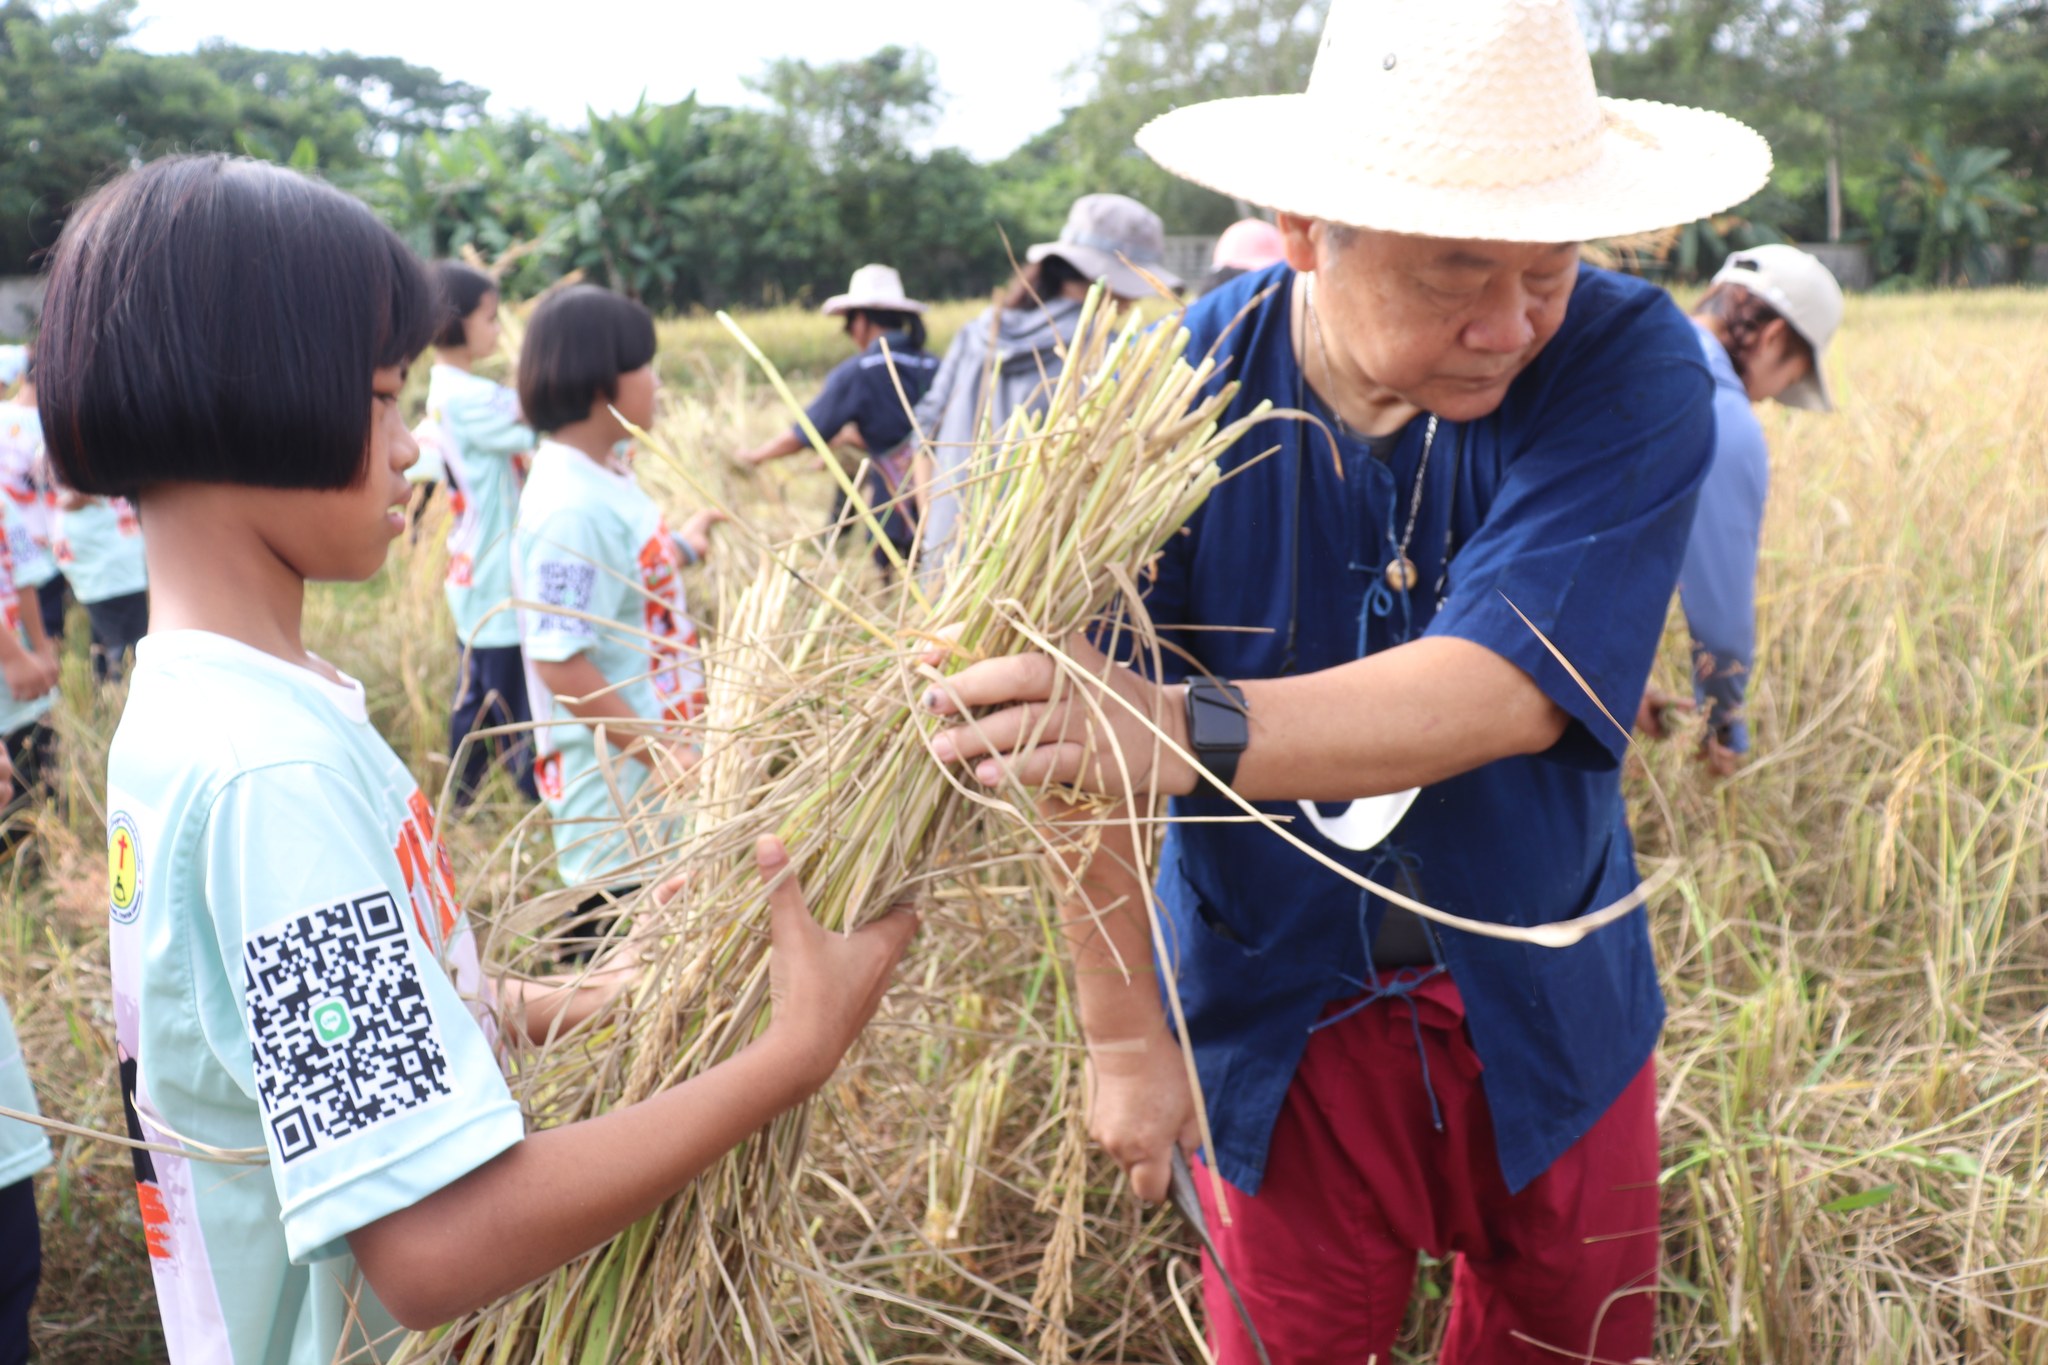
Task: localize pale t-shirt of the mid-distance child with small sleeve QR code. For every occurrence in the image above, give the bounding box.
[516,440,705,886]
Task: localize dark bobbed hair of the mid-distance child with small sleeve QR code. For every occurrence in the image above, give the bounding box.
[518,284,655,432]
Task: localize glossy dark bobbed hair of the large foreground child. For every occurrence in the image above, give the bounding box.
[37,156,434,495]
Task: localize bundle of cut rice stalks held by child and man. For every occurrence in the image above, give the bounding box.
[401,291,1264,1365]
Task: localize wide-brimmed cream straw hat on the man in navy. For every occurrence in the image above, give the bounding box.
[1137,0,1772,241]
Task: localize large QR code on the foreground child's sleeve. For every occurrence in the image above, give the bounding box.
[242,890,453,1162]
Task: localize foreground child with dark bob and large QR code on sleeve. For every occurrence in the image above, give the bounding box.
[41,156,911,1365]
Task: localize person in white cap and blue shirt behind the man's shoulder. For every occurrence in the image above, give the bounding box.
[1636,246,1841,778]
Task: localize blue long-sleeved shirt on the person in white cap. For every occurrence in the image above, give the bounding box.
[1677,327,1772,753]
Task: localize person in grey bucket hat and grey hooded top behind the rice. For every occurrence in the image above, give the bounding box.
[915,194,1182,579]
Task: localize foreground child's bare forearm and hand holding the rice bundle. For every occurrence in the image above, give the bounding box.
[348,839,915,1330]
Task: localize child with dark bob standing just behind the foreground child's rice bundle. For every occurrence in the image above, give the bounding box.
[516,284,719,913]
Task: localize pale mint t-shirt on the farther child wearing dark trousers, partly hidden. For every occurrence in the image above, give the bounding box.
[420,364,532,649]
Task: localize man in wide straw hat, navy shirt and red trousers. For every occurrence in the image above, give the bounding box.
[930,0,1769,1365]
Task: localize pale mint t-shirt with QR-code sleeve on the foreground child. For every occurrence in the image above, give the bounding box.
[106,630,524,1365]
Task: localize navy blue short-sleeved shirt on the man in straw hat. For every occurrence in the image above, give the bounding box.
[1147,266,1714,1193]
